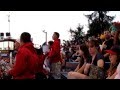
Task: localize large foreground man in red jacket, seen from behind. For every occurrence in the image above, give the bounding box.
[8,32,39,79]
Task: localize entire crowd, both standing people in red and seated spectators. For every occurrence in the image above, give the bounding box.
[0,30,120,79]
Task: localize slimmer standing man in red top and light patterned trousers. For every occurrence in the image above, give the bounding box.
[48,32,62,79]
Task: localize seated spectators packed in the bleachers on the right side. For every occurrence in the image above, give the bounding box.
[64,30,120,79]
